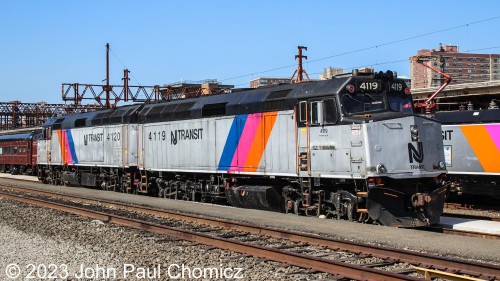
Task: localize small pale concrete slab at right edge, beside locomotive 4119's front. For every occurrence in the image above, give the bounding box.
[441,217,500,235]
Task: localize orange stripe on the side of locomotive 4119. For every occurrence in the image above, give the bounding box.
[243,112,278,172]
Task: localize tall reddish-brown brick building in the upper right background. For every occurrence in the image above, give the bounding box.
[410,45,500,89]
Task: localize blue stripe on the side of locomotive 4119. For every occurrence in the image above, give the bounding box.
[218,114,248,171]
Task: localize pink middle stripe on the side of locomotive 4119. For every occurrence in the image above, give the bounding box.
[229,113,262,171]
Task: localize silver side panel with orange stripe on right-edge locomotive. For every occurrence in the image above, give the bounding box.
[442,124,500,175]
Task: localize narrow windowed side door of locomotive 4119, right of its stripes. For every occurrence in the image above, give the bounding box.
[295,101,311,177]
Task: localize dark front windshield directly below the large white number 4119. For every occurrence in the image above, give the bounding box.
[342,93,386,114]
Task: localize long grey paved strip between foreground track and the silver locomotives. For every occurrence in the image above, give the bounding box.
[0,176,500,264]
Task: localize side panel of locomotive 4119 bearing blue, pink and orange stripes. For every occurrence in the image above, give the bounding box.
[216,111,296,175]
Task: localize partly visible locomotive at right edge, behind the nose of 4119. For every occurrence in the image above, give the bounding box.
[434,109,500,201]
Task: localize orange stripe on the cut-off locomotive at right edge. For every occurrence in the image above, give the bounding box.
[460,126,500,172]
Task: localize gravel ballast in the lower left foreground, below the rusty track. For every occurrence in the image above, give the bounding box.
[0,198,336,280]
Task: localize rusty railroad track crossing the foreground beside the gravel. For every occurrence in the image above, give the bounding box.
[0,183,500,280]
